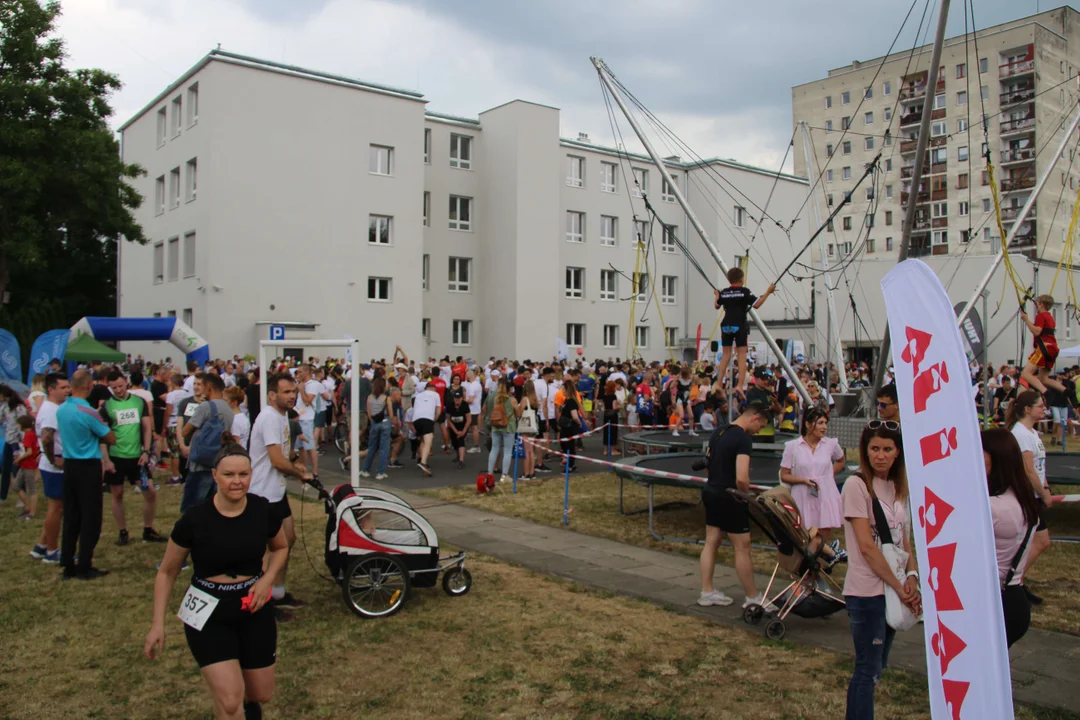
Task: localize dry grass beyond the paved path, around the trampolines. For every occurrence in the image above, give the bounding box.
[423,473,1080,635]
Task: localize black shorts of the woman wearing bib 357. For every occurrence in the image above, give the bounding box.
[184,578,278,670]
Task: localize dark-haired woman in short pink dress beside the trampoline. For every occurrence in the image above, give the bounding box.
[780,407,845,542]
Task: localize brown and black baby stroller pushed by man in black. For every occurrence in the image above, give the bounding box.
[728,486,845,640]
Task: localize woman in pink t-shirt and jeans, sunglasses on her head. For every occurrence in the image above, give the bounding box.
[840,420,920,720]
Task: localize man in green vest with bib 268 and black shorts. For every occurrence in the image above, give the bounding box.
[100,369,167,545]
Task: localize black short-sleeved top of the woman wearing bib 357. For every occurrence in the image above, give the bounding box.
[170,494,281,578]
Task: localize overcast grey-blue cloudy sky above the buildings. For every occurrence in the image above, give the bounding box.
[59,0,1062,167]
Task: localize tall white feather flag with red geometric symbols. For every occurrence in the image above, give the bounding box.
[881,260,1013,720]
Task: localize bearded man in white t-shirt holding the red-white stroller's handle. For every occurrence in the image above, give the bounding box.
[247,373,312,622]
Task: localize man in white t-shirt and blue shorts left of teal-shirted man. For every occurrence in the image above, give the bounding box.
[30,372,71,565]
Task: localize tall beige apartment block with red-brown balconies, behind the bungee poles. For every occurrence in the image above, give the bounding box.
[792,8,1080,363]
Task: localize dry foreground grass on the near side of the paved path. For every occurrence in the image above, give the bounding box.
[0,489,1077,720]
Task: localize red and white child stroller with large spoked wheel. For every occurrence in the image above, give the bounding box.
[309,480,472,617]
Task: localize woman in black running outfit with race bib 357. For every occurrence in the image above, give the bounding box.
[150,443,288,720]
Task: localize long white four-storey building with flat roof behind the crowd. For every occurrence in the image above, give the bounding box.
[117,50,822,359]
